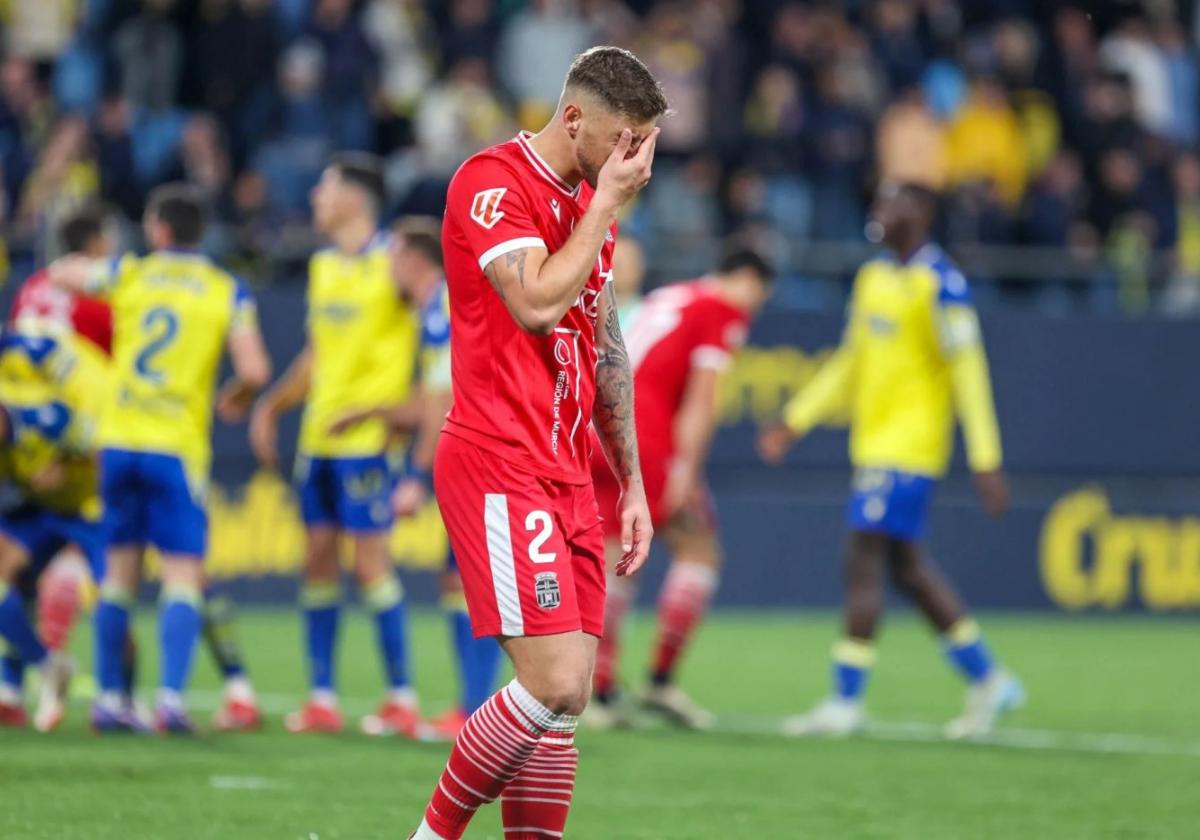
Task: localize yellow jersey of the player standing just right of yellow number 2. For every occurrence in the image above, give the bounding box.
[300,234,421,458]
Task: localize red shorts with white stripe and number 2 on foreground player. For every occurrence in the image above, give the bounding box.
[433,432,605,637]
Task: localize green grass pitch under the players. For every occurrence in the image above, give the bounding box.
[0,611,1200,840]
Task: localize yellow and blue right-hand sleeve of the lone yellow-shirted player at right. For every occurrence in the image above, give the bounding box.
[935,269,1003,473]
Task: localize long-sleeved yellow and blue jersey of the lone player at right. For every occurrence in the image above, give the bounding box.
[784,244,1001,478]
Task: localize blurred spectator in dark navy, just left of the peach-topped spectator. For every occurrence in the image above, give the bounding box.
[809,64,872,240]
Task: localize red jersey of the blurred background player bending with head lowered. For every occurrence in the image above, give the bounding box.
[625,280,748,461]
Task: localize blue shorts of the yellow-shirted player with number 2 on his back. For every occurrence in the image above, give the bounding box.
[100,449,209,558]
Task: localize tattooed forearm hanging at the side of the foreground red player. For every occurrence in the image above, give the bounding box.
[593,283,642,481]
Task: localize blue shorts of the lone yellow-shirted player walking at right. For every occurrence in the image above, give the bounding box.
[846,469,936,541]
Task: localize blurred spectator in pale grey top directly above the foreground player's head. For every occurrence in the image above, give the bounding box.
[497,0,592,128]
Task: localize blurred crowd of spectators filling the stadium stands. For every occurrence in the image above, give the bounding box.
[0,0,1200,312]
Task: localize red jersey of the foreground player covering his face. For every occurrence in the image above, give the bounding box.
[442,133,617,484]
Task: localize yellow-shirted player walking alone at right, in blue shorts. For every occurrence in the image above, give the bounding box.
[760,182,1024,738]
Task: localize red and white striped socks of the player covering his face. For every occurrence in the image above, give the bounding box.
[413,679,578,840]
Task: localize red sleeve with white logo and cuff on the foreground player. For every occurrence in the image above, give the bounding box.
[446,157,546,269]
